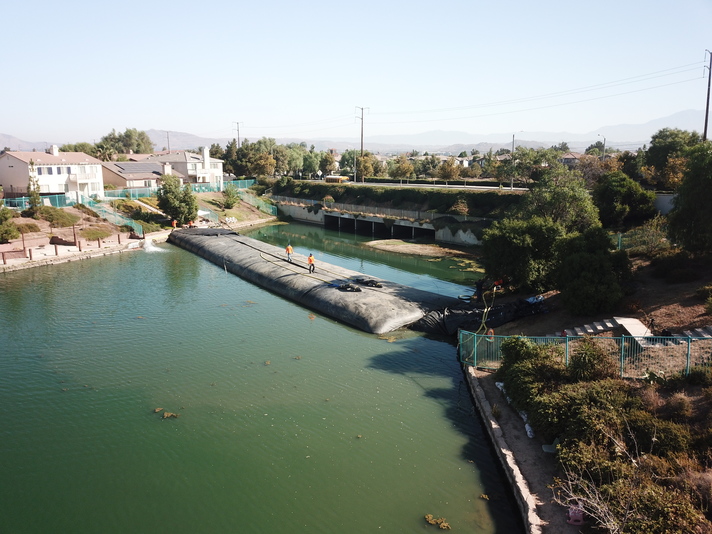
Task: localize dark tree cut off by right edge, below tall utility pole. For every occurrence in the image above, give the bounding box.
[668,141,712,254]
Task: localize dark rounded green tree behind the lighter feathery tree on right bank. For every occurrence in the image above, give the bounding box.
[593,171,655,228]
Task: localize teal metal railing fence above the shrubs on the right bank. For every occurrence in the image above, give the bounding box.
[458,330,712,378]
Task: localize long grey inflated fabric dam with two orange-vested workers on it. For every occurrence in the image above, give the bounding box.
[168,228,458,334]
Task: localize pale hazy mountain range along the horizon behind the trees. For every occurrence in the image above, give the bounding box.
[0,109,705,155]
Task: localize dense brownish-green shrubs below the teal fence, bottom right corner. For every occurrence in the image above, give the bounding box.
[497,337,712,534]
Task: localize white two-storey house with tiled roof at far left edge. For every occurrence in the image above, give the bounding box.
[0,145,104,198]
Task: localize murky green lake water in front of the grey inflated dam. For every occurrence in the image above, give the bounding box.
[0,225,522,534]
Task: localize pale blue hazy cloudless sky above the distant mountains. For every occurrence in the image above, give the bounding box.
[5,0,712,143]
